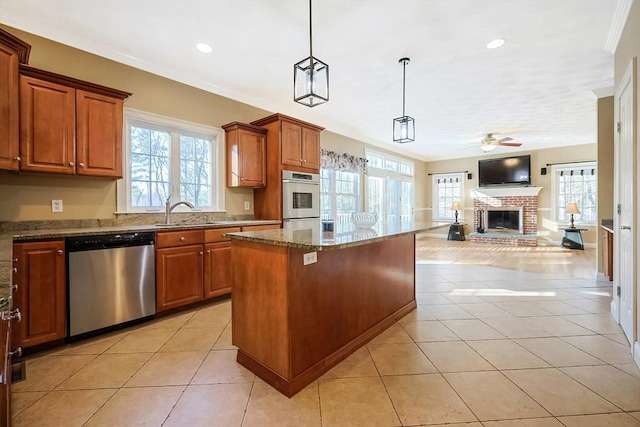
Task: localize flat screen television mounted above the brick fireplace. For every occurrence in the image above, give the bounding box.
[478,155,531,187]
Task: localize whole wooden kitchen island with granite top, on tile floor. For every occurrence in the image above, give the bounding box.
[228,223,448,397]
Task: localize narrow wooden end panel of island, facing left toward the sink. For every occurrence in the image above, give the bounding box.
[231,240,290,379]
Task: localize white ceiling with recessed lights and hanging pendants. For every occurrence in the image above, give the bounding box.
[0,0,616,161]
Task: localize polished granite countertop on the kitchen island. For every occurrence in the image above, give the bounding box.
[227,221,451,251]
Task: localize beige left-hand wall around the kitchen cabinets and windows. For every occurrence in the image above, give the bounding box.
[0,26,424,221]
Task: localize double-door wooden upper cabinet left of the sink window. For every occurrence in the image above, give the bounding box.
[19,65,131,178]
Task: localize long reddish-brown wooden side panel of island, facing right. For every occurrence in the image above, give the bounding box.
[289,234,415,377]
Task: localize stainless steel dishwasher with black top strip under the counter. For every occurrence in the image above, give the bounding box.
[66,232,156,340]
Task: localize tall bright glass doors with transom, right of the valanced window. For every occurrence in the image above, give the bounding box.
[365,150,415,222]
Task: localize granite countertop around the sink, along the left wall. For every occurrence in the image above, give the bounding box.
[0,220,280,311]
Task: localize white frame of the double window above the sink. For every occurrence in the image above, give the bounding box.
[116,108,226,214]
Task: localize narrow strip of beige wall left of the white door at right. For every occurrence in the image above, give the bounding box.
[597,96,614,272]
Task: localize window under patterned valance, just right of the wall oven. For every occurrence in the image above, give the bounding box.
[320,169,361,229]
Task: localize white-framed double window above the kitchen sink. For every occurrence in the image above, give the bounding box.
[118,109,224,212]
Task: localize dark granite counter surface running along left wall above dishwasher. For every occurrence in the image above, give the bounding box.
[0,219,280,311]
